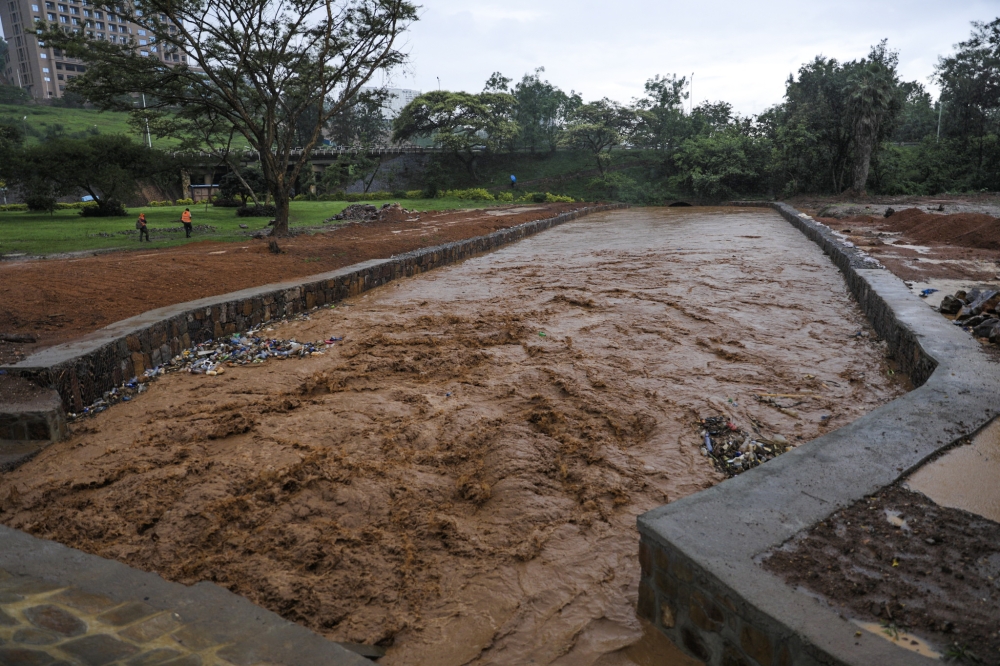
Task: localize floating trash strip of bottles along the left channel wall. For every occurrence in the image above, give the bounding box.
[67,315,344,421]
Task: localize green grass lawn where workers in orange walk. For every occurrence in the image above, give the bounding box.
[0,199,495,256]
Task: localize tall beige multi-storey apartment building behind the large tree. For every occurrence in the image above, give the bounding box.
[0,0,187,100]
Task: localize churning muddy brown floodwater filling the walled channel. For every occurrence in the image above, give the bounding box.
[0,208,902,666]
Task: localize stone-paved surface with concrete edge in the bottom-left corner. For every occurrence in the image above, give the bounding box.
[0,525,371,666]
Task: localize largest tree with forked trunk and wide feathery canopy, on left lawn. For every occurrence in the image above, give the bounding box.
[42,0,417,234]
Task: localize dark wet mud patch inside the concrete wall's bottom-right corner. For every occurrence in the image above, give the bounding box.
[764,487,1000,666]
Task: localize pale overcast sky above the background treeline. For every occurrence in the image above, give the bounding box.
[380,0,1000,114]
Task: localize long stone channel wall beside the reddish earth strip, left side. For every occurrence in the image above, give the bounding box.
[0,204,627,412]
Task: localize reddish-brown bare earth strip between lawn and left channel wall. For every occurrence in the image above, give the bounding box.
[0,204,584,363]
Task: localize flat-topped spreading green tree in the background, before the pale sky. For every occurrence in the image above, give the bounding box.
[393,90,518,178]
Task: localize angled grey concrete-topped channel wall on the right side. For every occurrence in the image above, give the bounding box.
[638,203,1000,666]
